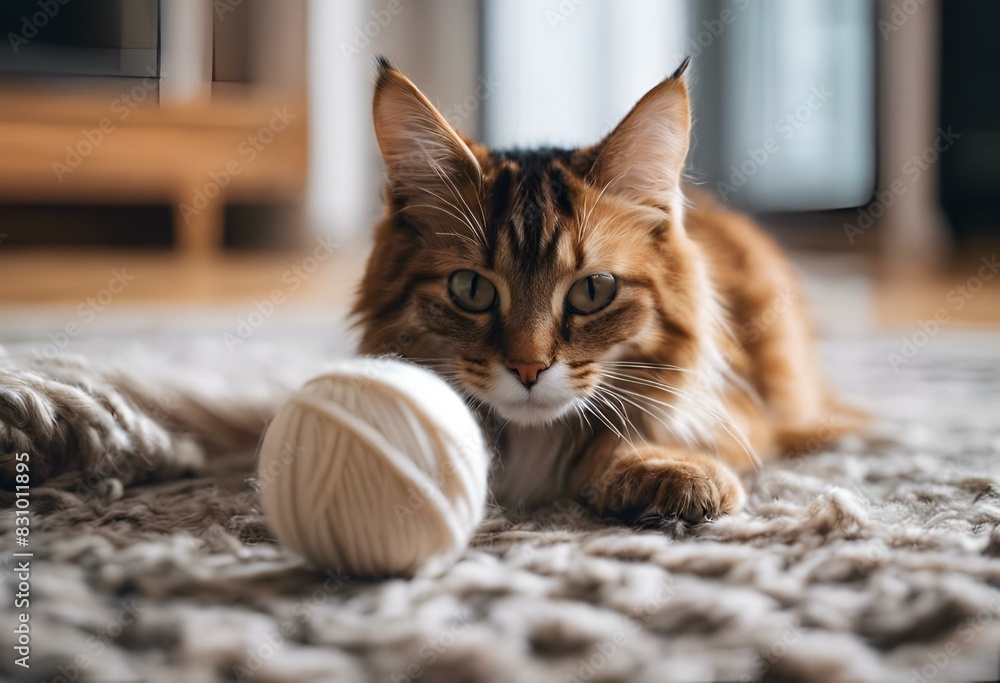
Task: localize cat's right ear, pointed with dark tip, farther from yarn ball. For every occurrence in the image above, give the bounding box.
[596,57,691,206]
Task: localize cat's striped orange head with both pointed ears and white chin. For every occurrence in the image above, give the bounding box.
[355,60,707,424]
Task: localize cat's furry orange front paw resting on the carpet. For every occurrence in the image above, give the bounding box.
[588,449,745,524]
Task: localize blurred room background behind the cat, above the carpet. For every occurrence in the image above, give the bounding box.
[0,0,1000,350]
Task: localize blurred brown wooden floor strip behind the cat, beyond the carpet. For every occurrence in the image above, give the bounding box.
[0,245,1000,332]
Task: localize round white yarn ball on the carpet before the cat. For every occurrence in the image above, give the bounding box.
[258,358,489,577]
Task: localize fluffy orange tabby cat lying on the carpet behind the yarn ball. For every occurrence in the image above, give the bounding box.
[353,57,857,525]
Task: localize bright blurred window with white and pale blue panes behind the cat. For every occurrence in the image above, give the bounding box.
[483,0,876,211]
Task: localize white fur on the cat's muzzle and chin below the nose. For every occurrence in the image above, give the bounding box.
[477,363,576,426]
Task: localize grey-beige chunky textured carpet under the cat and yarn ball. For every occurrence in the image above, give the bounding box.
[0,328,1000,683]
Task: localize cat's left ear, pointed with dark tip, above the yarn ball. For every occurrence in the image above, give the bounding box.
[372,57,482,194]
